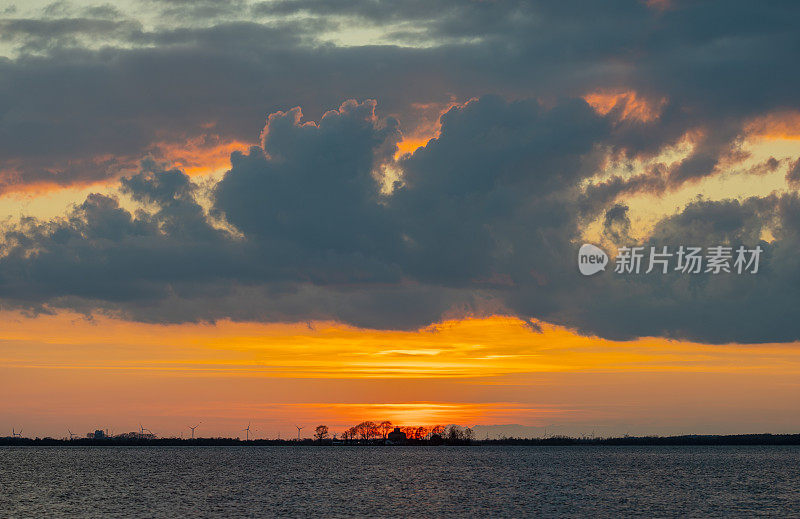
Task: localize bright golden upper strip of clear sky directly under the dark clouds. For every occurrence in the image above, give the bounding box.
[0,313,800,378]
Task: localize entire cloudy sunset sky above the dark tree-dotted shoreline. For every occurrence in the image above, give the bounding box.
[0,0,800,438]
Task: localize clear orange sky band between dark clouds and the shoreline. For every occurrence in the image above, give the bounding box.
[0,313,800,437]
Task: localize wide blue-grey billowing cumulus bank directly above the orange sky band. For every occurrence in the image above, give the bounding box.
[0,96,800,342]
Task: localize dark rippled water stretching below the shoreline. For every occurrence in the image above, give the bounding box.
[0,447,800,517]
